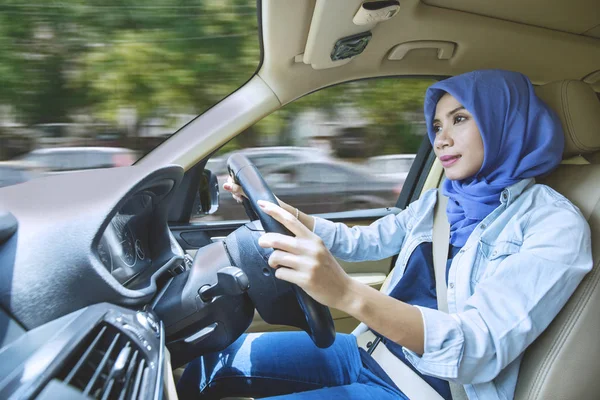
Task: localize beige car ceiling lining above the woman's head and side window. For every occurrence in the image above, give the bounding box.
[258,0,600,104]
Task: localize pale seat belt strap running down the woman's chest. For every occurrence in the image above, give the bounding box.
[431,189,468,400]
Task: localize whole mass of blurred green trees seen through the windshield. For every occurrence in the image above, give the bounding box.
[0,0,260,133]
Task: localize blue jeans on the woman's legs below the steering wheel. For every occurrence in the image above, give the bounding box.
[177,332,407,400]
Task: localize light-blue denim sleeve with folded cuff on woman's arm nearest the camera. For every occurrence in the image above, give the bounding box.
[404,202,592,384]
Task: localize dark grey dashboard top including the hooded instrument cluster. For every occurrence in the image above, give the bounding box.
[0,165,184,329]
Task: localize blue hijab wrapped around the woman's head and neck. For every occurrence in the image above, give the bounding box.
[424,70,564,247]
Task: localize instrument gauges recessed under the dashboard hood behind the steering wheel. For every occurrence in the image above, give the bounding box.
[96,193,153,285]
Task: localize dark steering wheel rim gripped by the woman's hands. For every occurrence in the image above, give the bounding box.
[227,154,335,348]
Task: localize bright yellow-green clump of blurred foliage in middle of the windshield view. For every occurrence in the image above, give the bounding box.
[76,32,194,136]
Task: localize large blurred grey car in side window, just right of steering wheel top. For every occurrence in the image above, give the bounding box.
[215,160,401,219]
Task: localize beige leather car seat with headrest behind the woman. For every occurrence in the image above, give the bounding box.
[515,81,600,400]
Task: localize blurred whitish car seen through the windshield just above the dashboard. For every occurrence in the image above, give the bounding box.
[18,147,138,172]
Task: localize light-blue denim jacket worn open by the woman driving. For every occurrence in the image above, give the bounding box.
[314,179,592,400]
